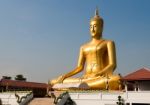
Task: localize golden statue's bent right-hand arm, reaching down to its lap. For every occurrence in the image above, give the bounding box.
[96,41,116,76]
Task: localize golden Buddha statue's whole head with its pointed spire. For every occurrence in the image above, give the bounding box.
[90,9,103,38]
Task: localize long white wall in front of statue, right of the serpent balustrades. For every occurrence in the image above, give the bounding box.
[69,91,150,105]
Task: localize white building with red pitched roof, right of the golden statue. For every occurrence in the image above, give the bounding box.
[123,68,150,91]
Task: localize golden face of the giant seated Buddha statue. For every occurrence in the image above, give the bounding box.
[90,20,102,37]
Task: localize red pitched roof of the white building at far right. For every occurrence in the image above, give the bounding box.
[122,68,150,81]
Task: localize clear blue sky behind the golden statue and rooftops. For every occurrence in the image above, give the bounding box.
[0,0,150,82]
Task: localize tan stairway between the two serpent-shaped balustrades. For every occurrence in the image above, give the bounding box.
[28,98,54,105]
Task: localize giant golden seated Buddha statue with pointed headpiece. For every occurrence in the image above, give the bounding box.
[49,10,120,90]
